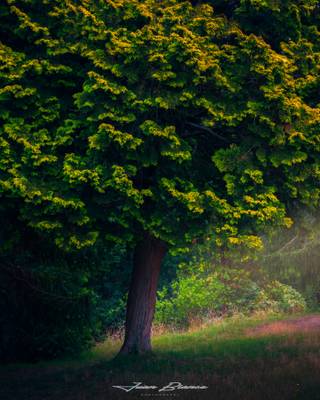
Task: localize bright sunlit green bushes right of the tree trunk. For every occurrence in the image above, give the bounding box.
[155,265,306,326]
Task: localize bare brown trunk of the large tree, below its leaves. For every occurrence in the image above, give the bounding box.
[120,234,166,354]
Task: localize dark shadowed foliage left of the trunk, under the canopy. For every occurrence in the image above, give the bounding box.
[0,242,130,362]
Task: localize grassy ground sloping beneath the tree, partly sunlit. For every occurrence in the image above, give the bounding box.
[0,315,320,400]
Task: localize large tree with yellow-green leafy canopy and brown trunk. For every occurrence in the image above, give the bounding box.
[0,0,320,353]
